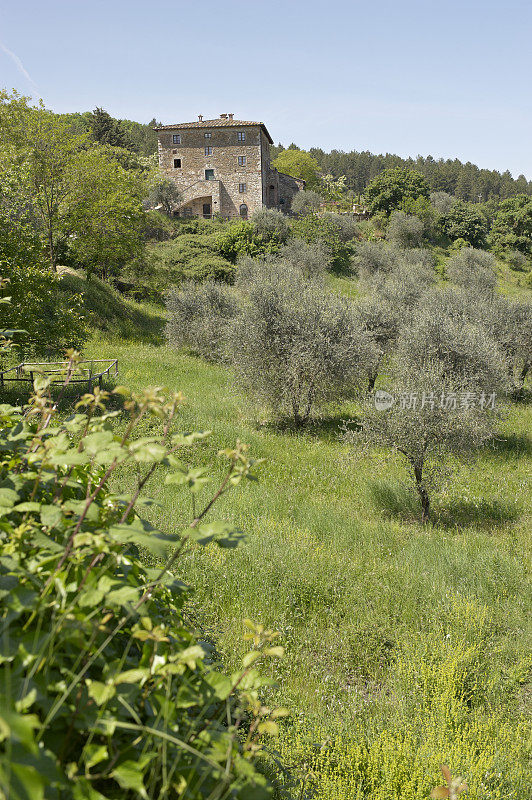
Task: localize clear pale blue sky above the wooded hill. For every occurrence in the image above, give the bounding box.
[0,0,532,179]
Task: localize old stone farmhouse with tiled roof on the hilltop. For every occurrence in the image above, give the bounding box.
[156,114,305,219]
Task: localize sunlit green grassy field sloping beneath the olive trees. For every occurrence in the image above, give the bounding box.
[75,268,532,800]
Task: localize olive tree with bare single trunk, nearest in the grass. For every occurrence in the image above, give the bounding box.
[354,362,497,522]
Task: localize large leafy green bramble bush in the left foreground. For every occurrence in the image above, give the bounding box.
[0,374,285,800]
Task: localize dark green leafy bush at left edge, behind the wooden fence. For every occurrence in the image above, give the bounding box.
[0,261,88,358]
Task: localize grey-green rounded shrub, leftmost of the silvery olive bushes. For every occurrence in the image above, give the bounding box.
[166,281,237,361]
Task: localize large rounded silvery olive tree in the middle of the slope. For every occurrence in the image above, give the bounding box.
[227,265,375,425]
